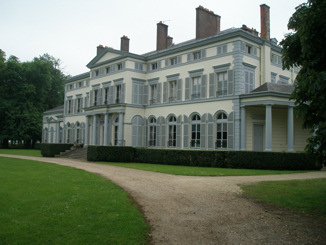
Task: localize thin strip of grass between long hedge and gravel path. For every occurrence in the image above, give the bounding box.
[101,162,308,176]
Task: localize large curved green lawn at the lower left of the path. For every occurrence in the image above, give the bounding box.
[0,157,149,244]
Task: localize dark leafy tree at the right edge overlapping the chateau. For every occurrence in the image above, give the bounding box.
[280,0,326,163]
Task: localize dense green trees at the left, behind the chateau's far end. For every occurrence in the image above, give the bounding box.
[0,50,66,147]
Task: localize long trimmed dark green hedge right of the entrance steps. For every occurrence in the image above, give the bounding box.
[87,146,322,170]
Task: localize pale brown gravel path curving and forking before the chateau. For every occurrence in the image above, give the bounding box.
[0,154,326,245]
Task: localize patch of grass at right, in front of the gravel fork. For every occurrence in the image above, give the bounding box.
[241,179,326,219]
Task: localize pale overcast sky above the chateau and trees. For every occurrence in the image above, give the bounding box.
[0,0,306,76]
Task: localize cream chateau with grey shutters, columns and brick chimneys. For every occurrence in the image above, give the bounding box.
[43,4,309,151]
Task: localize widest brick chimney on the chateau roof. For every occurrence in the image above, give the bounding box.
[196,6,221,39]
